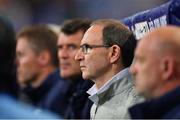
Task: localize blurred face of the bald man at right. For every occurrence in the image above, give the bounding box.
[131,40,161,97]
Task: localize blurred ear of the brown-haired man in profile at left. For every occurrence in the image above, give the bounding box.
[38,51,51,66]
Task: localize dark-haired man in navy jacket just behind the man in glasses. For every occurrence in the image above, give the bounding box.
[44,19,92,119]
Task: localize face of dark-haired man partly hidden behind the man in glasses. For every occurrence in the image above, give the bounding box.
[58,31,83,78]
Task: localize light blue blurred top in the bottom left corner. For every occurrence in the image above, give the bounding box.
[0,93,58,119]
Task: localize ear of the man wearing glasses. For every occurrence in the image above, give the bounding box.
[110,45,121,63]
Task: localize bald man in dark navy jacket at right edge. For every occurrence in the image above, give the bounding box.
[129,26,180,119]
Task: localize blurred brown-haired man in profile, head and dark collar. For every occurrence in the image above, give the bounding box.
[16,25,60,107]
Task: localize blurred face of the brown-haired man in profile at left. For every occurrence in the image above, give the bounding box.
[16,37,40,85]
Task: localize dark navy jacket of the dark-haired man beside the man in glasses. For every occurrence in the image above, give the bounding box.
[43,78,92,119]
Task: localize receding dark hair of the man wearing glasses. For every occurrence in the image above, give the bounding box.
[91,19,137,67]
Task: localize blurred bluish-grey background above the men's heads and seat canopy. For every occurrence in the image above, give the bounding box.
[0,0,168,30]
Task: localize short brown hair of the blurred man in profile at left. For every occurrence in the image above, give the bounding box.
[16,25,58,66]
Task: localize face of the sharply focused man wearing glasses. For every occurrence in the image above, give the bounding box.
[75,25,110,80]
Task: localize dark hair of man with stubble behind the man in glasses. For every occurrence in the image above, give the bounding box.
[61,18,92,35]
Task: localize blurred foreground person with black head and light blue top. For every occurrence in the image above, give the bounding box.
[0,17,57,119]
